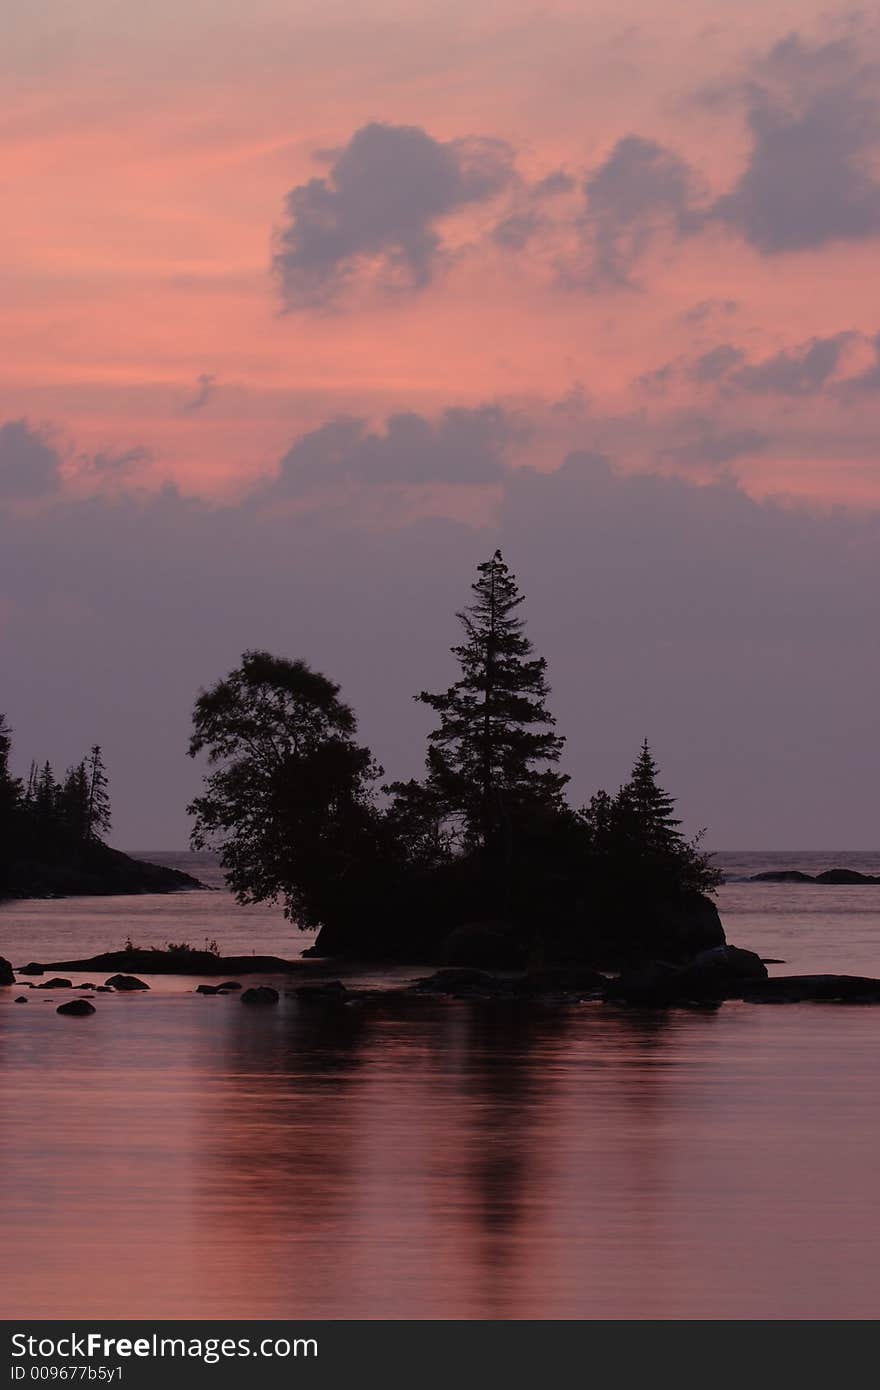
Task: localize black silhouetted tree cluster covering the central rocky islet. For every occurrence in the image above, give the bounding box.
[189,552,720,958]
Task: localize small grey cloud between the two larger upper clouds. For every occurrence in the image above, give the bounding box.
[581,135,701,286]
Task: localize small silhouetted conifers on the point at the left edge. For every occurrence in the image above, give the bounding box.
[0,714,111,897]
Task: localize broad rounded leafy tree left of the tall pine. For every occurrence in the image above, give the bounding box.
[189,651,381,927]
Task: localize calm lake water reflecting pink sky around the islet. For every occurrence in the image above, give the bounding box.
[0,852,880,1319]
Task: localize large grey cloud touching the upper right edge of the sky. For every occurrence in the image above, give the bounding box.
[712,33,880,256]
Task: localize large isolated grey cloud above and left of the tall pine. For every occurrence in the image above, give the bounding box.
[274,122,514,309]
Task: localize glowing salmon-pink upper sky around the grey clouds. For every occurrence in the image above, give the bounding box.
[6,0,880,503]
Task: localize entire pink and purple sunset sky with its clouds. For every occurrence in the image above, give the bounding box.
[0,0,880,849]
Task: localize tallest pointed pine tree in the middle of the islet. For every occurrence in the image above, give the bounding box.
[416,550,569,859]
